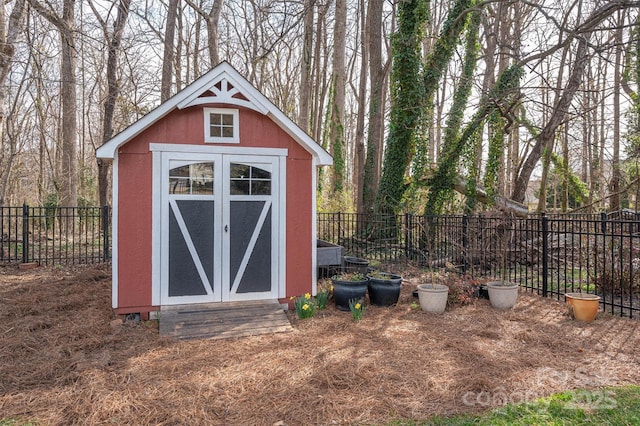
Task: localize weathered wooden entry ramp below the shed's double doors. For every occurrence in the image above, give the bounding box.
[158,300,293,339]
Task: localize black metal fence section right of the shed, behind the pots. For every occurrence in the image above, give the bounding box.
[318,213,640,317]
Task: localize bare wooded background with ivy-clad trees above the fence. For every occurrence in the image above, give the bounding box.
[0,0,640,213]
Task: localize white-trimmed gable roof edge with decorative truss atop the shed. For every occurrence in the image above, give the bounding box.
[96,62,333,166]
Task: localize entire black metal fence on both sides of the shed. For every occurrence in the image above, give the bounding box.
[0,205,640,317]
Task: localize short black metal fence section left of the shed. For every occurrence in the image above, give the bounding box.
[0,204,111,265]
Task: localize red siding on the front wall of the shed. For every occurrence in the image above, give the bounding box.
[118,105,315,312]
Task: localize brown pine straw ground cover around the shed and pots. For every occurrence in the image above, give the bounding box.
[0,267,640,425]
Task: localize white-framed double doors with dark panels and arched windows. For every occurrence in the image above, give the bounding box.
[161,152,279,304]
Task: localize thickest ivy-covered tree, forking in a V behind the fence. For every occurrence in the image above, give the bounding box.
[376,0,475,213]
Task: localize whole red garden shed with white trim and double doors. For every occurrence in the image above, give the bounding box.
[97,62,332,315]
